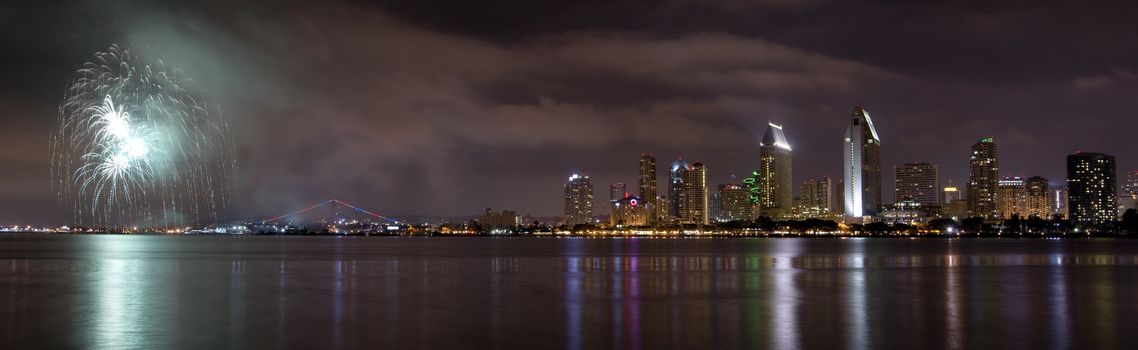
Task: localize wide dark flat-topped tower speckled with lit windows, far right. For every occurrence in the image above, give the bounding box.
[1067,152,1118,226]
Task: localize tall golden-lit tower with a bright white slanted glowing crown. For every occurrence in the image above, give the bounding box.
[759,123,794,217]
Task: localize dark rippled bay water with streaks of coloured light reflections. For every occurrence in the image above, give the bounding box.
[0,235,1138,349]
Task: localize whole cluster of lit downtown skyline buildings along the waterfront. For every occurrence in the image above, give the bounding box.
[562,107,1138,232]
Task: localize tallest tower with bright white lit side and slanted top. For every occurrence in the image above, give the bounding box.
[842,107,881,217]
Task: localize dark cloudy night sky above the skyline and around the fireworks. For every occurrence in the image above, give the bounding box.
[0,0,1138,225]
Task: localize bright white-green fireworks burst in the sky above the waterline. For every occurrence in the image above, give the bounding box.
[51,45,236,227]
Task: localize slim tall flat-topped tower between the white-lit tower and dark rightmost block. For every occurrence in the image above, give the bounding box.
[967,138,999,218]
